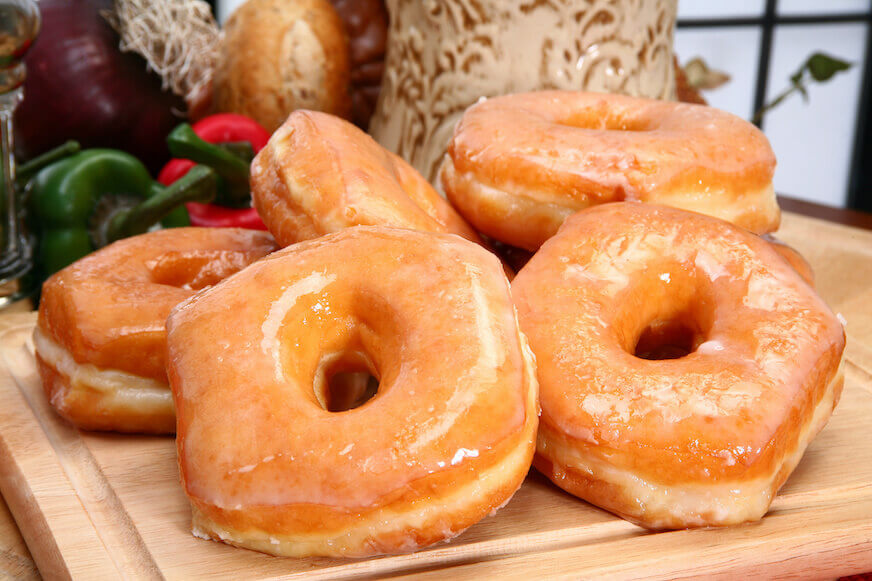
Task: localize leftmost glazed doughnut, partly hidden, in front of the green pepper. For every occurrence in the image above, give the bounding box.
[33,228,275,434]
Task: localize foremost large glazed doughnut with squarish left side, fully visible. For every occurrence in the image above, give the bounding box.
[167,227,538,557]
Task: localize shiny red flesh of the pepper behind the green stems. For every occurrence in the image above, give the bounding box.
[157,113,270,230]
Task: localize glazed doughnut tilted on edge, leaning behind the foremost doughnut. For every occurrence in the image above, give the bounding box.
[251,111,480,246]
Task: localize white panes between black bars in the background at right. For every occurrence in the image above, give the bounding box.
[675,0,870,206]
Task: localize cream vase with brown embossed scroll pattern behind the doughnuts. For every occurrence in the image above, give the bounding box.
[370,0,677,181]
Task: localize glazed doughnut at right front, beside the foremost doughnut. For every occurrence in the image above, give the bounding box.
[512,202,845,529]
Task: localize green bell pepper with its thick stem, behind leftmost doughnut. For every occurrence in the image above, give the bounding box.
[27,149,217,276]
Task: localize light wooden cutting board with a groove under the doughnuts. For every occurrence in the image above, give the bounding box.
[0,215,872,579]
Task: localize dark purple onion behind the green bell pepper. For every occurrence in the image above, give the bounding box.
[15,0,185,172]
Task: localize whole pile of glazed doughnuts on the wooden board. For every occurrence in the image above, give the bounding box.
[36,92,845,557]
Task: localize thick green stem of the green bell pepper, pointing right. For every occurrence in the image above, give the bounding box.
[105,165,218,244]
